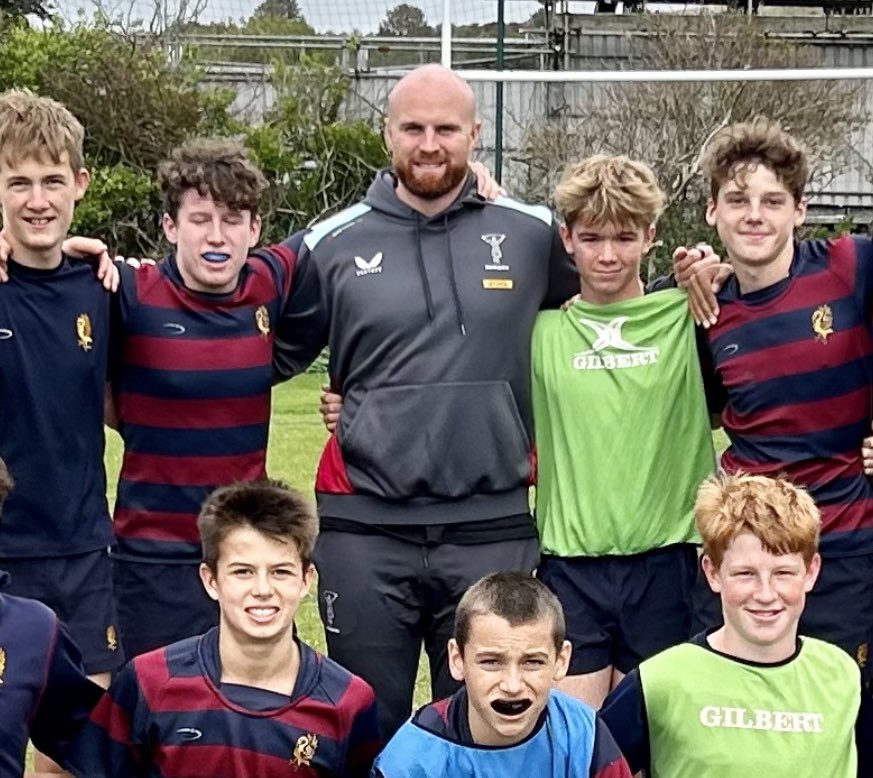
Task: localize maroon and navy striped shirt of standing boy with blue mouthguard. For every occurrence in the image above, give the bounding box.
[112,244,297,563]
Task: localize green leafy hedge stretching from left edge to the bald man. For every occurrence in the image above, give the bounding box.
[0,17,386,256]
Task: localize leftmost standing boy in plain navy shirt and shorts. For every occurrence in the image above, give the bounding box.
[0,91,124,728]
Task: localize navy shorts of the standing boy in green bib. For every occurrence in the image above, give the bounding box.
[537,543,697,675]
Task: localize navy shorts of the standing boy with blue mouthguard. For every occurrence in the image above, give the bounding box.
[115,558,218,658]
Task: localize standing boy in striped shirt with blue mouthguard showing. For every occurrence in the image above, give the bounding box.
[111,140,320,656]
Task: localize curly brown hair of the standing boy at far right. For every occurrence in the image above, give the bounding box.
[700,116,809,203]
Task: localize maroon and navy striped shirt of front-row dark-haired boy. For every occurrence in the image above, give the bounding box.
[65,628,380,778]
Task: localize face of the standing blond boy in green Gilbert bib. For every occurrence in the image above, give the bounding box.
[561,219,655,305]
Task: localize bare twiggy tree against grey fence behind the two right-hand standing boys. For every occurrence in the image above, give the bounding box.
[520,14,868,269]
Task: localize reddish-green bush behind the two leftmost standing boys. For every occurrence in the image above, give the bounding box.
[0,22,240,256]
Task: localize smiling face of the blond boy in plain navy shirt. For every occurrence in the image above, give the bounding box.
[0,152,89,268]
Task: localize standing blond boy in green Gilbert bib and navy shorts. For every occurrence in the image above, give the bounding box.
[531,155,714,708]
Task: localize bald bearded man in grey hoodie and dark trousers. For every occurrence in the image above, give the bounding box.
[275,65,578,737]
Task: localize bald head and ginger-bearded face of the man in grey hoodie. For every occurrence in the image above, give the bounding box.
[385,66,480,214]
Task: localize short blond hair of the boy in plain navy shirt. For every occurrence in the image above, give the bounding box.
[0,89,85,171]
